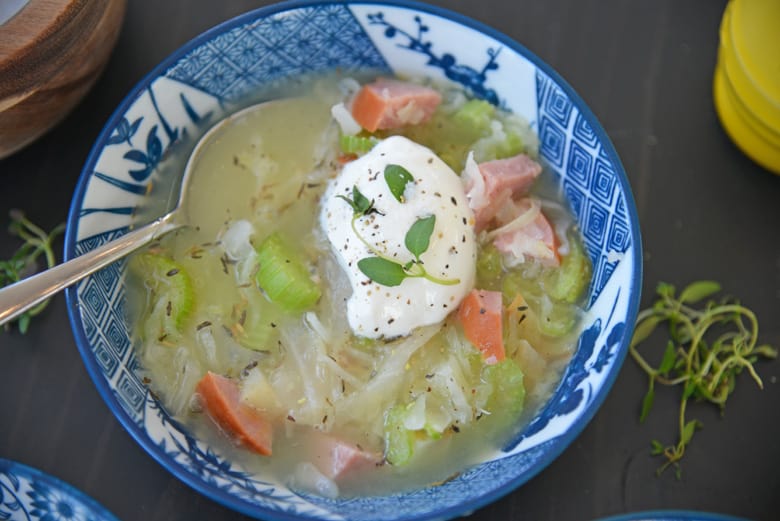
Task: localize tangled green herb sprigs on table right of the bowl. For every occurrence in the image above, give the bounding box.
[629,281,777,479]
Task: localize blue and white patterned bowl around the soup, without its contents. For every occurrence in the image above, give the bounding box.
[66,0,641,520]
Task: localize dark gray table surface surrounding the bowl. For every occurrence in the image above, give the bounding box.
[0,0,780,521]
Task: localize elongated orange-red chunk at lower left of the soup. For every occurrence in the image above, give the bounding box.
[195,371,273,456]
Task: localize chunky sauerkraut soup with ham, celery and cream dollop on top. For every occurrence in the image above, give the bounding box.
[128,77,590,497]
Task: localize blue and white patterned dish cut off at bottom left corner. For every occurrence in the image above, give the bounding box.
[0,459,118,521]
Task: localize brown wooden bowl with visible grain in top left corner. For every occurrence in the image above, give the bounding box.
[0,0,126,159]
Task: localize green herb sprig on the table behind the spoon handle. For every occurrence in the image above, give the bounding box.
[0,210,65,333]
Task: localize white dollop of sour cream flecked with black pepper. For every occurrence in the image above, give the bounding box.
[320,136,477,338]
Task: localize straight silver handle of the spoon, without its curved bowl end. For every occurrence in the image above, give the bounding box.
[0,212,181,326]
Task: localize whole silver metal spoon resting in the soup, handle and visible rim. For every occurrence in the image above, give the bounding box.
[0,102,278,326]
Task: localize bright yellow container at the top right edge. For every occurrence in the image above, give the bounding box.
[713,0,780,174]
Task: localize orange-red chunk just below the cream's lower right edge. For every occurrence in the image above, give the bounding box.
[458,289,506,364]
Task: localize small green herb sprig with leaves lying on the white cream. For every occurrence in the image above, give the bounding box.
[338,178,460,286]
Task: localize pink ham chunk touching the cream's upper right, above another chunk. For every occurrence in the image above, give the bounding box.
[466,154,542,233]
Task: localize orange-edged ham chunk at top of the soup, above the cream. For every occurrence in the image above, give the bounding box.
[352,78,441,132]
